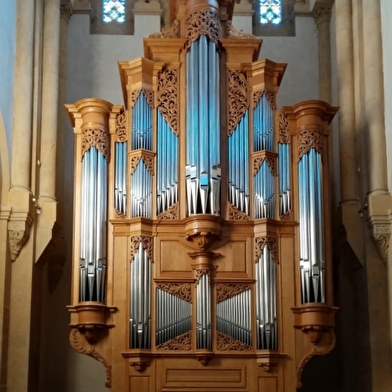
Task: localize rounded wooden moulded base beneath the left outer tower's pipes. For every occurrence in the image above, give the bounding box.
[68,301,117,344]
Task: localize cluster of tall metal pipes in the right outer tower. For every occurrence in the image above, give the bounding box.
[298,148,325,303]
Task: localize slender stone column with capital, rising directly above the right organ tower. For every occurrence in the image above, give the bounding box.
[313,0,332,103]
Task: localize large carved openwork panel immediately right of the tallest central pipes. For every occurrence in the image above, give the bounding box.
[227,70,249,136]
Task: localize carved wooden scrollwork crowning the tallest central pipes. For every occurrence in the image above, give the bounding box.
[185,10,220,49]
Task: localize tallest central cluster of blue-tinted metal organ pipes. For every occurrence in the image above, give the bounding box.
[185,35,221,215]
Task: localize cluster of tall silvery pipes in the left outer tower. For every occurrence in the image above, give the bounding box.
[80,147,107,302]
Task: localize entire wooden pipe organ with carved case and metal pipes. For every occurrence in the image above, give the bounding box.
[66,0,337,392]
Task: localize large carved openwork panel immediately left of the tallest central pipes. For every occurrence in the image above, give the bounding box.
[158,69,178,136]
